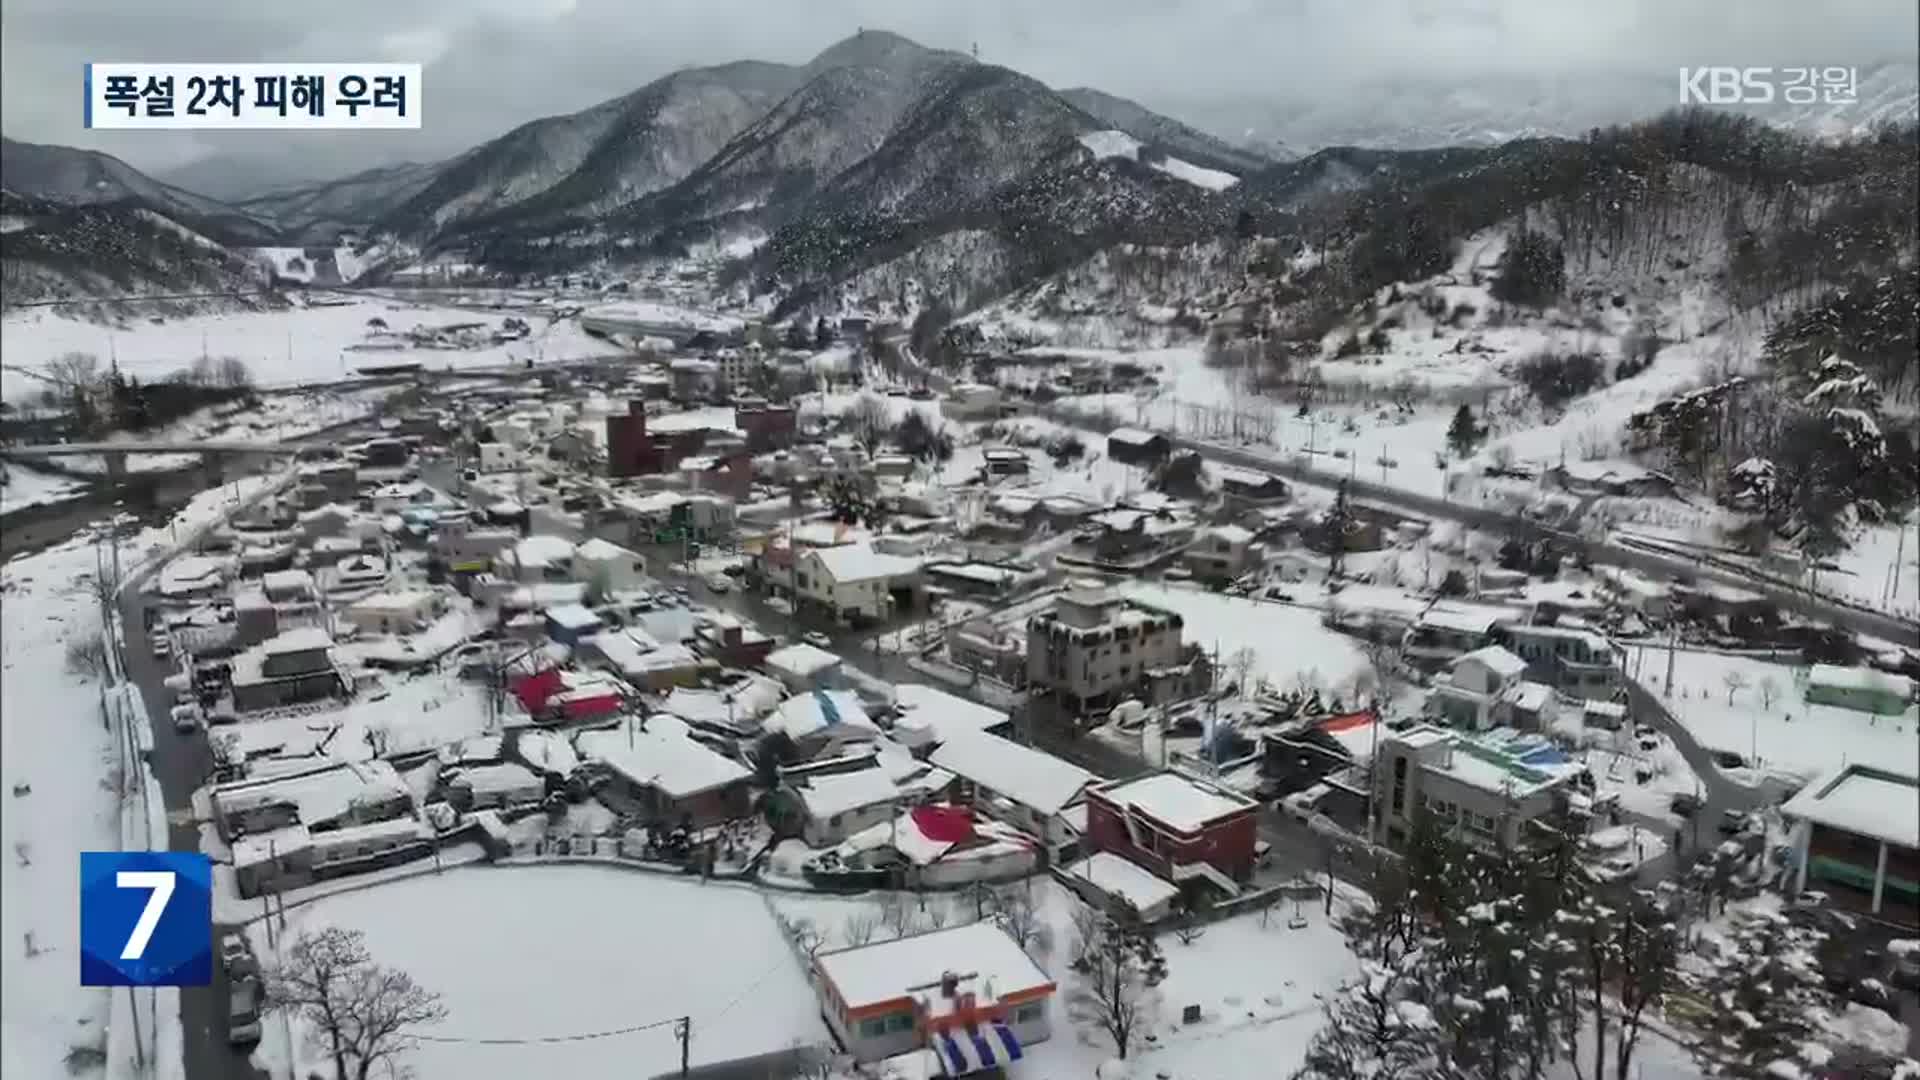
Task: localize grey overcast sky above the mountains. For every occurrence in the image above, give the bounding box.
[0,0,1920,179]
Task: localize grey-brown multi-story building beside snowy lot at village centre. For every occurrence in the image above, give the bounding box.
[1027,588,1185,713]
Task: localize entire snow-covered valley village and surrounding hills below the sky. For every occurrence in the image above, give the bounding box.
[0,15,1920,1080]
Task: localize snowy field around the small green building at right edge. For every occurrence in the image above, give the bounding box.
[1626,646,1920,778]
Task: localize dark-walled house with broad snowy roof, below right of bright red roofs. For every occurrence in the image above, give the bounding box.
[576,715,753,826]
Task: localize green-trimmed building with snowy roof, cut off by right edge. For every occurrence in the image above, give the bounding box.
[1780,761,1920,926]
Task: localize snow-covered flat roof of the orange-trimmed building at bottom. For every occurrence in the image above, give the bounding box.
[814,922,1054,1009]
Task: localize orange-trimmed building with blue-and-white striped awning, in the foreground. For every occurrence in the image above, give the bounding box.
[812,922,1056,1076]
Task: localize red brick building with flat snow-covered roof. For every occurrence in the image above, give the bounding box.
[1087,773,1260,896]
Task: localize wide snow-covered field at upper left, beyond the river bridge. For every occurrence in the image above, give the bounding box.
[0,298,614,400]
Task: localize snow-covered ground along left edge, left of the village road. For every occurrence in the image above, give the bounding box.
[0,479,257,1078]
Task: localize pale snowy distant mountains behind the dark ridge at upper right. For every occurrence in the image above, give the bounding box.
[1164,61,1920,156]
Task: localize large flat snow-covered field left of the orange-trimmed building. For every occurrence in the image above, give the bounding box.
[253,867,828,1080]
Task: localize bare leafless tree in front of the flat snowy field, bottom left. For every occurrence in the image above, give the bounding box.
[265,926,447,1080]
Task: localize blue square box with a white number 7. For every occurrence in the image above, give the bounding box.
[81,851,213,986]
